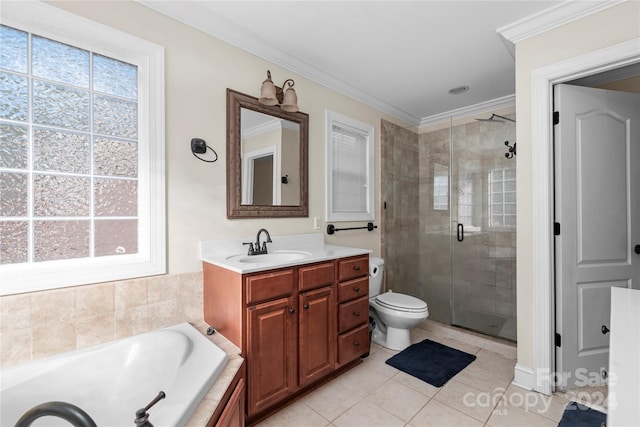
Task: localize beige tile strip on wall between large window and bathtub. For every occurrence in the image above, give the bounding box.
[0,272,203,367]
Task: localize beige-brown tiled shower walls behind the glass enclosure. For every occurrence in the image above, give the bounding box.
[381,115,516,339]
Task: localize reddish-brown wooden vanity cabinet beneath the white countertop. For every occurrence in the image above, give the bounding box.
[203,256,369,421]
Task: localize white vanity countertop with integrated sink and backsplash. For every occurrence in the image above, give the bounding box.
[200,233,372,274]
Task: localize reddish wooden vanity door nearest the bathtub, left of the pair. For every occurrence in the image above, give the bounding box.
[247,297,297,415]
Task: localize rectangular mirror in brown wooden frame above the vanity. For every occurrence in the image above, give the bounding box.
[227,89,309,218]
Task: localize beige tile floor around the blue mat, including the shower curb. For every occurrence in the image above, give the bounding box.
[258,320,596,427]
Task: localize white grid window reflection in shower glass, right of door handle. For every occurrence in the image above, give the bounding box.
[489,168,516,228]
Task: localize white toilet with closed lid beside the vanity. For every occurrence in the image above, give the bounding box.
[369,257,429,350]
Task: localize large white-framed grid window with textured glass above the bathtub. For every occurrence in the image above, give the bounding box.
[0,2,166,294]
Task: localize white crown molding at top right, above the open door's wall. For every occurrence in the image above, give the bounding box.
[496,0,625,43]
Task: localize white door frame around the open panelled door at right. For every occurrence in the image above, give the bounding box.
[528,38,640,395]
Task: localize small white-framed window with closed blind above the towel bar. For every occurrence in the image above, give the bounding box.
[327,111,375,221]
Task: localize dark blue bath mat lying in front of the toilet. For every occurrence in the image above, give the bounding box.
[386,340,476,387]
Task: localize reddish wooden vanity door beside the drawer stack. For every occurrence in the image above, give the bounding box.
[298,287,336,386]
